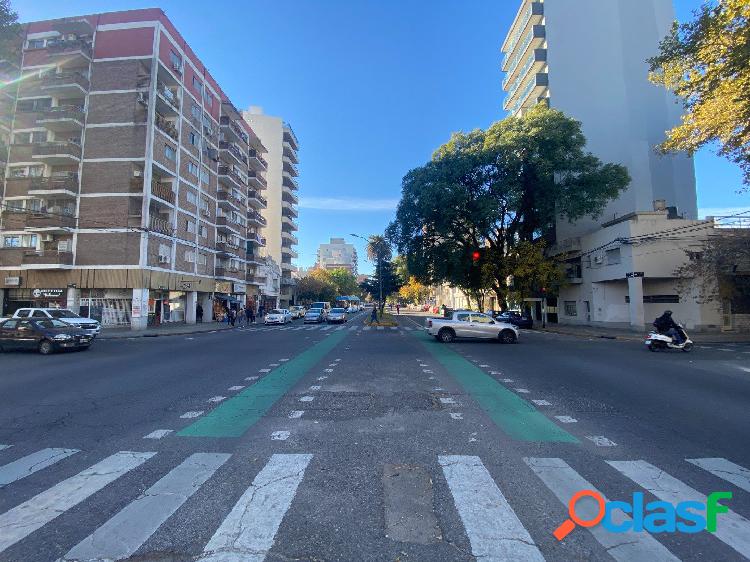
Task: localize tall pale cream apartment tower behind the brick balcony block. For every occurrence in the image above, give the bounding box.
[243,106,299,309]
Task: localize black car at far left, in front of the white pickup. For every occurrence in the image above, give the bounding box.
[0,318,94,355]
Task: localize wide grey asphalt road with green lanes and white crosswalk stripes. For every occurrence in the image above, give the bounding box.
[0,315,750,562]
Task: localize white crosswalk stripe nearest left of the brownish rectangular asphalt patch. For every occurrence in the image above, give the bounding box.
[199,455,312,562]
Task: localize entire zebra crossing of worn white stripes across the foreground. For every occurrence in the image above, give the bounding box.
[0,447,750,562]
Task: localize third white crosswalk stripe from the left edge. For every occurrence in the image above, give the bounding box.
[63,453,231,561]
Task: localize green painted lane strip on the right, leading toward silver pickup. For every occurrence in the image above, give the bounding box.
[415,332,579,443]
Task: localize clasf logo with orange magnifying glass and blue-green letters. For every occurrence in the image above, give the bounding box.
[553,490,732,541]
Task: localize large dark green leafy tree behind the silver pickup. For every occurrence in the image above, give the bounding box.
[388,104,630,305]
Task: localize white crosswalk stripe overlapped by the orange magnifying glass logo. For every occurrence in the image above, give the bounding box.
[523,458,679,562]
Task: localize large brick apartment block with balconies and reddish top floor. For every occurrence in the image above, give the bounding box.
[0,9,267,329]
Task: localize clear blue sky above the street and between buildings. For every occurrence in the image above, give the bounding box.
[20,0,750,272]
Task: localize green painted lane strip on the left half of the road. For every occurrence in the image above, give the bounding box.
[177,330,347,437]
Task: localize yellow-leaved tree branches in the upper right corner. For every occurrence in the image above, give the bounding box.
[648,0,750,189]
